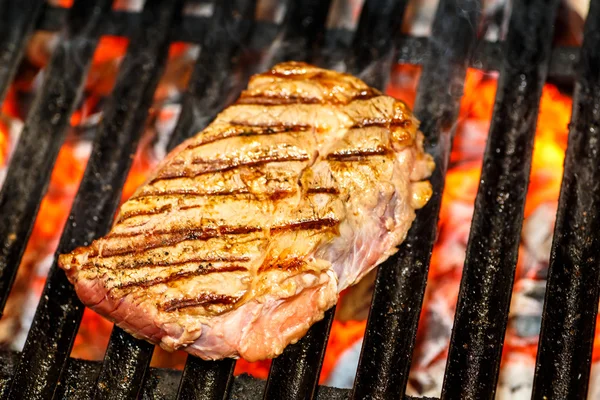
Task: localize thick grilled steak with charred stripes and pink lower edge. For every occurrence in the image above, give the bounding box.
[59,62,434,361]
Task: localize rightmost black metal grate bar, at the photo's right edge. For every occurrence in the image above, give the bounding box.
[533,1,600,399]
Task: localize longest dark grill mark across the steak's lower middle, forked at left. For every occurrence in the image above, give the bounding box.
[98,218,340,257]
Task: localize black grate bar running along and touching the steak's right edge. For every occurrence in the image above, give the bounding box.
[352,0,481,399]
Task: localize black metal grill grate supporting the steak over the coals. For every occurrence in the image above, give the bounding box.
[0,0,600,399]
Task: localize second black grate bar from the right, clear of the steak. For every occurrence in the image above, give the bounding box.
[442,0,558,399]
